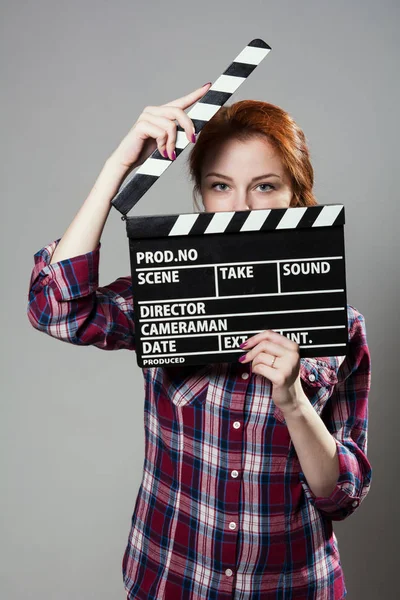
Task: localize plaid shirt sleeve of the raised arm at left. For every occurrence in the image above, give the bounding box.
[27,238,136,350]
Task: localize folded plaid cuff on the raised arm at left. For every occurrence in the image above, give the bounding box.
[30,238,101,302]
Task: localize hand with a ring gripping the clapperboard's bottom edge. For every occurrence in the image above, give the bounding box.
[240,330,304,410]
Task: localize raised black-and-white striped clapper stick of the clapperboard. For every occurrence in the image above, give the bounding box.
[111,39,271,220]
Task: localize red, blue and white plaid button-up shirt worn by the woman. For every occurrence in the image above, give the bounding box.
[27,239,372,600]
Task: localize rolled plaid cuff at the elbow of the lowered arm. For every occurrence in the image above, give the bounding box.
[299,437,372,520]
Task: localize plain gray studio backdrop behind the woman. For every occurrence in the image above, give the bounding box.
[0,0,399,600]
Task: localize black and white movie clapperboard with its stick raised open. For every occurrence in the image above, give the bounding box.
[112,39,348,367]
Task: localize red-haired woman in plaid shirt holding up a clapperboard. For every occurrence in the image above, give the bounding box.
[28,84,372,600]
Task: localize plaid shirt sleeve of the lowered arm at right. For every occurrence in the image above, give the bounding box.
[300,307,372,521]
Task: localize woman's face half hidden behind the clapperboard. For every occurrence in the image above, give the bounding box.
[201,137,293,212]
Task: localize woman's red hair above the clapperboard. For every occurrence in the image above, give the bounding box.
[187,100,318,209]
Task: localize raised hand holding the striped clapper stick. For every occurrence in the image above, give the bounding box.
[106,82,211,171]
